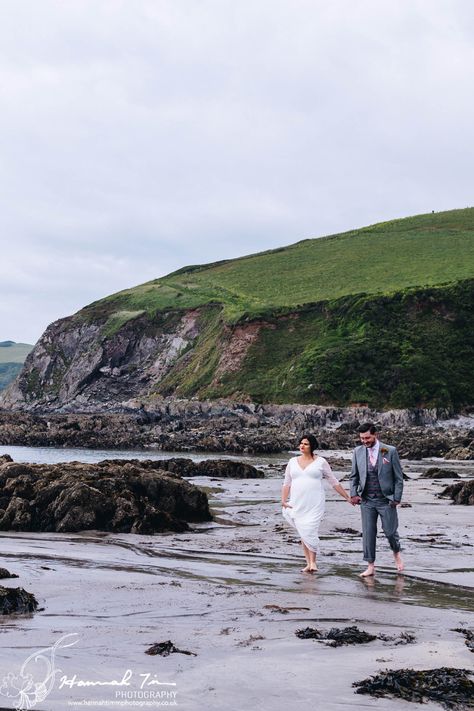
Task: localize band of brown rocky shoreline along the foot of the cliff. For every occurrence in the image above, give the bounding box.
[0,400,474,460]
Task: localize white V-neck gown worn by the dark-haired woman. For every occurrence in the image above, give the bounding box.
[282,455,339,553]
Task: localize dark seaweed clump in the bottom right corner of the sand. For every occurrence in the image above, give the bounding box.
[352,667,474,709]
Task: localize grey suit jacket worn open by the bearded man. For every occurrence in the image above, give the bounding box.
[351,442,403,501]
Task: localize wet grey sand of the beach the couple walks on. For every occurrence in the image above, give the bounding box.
[0,453,474,711]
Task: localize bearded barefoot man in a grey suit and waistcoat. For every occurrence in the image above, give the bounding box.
[351,422,403,578]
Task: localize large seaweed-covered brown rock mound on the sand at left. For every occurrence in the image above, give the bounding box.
[0,460,211,534]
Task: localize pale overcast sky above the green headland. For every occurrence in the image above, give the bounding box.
[0,0,474,343]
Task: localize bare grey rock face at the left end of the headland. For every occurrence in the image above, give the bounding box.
[2,309,206,412]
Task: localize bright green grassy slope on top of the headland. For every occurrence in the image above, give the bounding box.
[79,208,474,330]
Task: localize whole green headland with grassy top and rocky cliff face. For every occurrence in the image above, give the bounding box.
[10,208,474,410]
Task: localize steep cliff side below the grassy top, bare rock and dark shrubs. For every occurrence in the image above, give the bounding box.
[1,280,474,412]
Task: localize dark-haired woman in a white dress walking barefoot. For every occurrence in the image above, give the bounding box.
[281,434,351,573]
